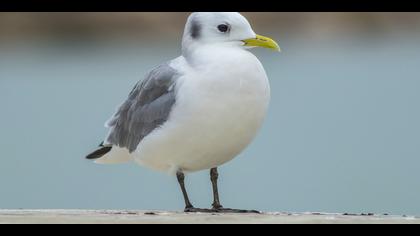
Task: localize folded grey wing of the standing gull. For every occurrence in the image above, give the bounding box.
[105,63,179,153]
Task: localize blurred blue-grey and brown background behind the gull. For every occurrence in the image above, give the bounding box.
[0,12,420,215]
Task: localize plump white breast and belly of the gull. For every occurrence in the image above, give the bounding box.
[132,49,270,173]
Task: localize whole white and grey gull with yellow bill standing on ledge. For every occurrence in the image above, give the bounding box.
[86,12,280,213]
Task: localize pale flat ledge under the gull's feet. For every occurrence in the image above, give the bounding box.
[0,210,420,224]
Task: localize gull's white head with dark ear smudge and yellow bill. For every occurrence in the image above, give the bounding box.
[182,12,280,54]
